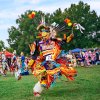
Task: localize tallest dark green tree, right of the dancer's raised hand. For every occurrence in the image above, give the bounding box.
[64,1,100,48]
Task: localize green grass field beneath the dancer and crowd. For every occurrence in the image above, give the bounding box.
[0,66,100,100]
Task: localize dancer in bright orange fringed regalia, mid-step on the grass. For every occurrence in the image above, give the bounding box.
[28,13,77,96]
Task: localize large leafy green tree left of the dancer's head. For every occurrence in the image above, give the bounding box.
[8,10,47,54]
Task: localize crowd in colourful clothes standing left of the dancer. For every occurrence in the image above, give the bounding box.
[0,50,29,76]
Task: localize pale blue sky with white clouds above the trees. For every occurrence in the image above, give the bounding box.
[0,0,100,46]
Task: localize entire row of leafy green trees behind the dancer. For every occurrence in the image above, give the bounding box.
[1,1,100,54]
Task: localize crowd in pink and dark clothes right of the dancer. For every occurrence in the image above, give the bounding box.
[66,49,100,67]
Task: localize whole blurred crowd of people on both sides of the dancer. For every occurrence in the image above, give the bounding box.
[0,49,100,76]
